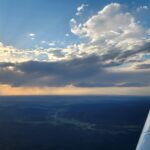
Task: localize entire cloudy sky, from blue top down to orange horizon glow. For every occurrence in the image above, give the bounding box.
[0,0,150,95]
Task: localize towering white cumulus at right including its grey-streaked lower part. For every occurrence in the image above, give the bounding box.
[70,3,150,69]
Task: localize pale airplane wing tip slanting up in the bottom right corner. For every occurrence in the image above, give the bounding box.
[136,112,150,150]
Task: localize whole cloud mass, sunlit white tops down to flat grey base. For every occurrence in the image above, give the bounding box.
[0,3,150,92]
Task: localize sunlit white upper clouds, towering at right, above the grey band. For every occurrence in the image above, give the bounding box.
[0,3,150,64]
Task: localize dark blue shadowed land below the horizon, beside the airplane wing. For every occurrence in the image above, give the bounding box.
[0,96,150,150]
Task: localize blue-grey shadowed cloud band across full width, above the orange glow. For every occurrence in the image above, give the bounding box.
[0,51,150,87]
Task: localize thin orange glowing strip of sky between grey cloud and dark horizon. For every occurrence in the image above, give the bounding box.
[0,84,150,96]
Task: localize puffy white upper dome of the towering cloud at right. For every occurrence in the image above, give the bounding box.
[70,3,148,49]
